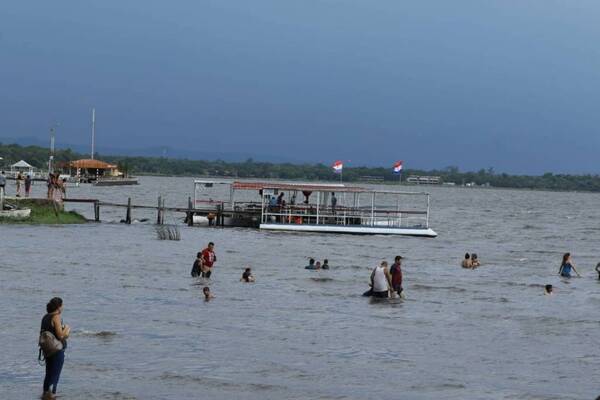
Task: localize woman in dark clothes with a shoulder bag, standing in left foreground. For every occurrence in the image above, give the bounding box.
[40,297,71,400]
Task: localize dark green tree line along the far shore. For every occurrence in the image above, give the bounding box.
[0,143,600,192]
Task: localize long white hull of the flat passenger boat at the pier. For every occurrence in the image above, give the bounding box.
[260,224,437,237]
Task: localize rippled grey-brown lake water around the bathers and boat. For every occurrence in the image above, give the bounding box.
[0,177,600,399]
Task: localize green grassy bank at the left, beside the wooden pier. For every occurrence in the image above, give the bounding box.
[0,199,87,225]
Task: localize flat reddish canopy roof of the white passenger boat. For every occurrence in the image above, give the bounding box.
[231,181,429,195]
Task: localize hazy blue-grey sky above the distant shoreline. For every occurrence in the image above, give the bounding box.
[0,0,600,174]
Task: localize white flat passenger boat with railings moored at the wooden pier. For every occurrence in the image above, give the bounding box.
[194,180,437,237]
